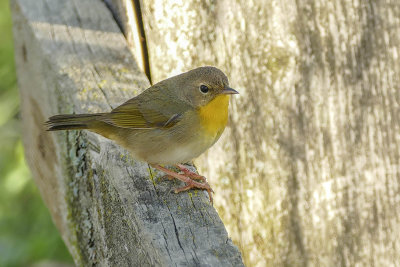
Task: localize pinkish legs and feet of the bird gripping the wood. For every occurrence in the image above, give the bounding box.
[152,165,214,204]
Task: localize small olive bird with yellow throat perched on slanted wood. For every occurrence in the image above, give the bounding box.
[46,67,238,202]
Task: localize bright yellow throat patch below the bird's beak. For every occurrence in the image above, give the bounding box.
[199,95,229,137]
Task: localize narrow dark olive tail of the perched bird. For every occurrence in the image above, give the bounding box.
[46,113,103,131]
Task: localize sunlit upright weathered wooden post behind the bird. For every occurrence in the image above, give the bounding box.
[108,0,400,266]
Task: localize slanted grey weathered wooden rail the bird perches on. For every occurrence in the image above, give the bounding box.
[11,0,243,266]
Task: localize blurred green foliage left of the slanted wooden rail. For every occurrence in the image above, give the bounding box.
[0,0,72,266]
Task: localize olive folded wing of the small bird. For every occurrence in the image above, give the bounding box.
[103,88,190,129]
